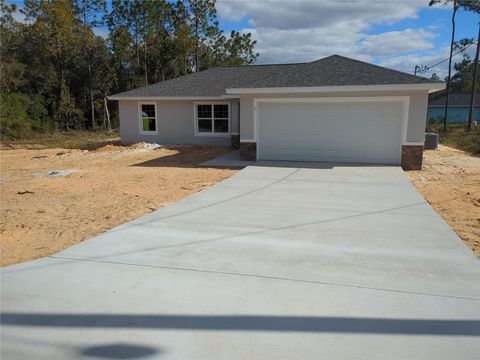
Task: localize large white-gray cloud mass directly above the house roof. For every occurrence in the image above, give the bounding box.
[218,0,443,73]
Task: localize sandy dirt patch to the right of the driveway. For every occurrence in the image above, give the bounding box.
[406,145,480,257]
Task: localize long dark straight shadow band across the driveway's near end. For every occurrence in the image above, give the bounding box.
[1,312,480,336]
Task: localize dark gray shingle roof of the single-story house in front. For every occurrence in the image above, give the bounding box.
[110,55,441,97]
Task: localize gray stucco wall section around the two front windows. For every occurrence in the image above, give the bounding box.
[118,99,239,145]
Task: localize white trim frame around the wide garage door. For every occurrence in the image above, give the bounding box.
[253,96,410,164]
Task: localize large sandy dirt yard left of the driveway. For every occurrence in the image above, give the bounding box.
[0,144,236,266]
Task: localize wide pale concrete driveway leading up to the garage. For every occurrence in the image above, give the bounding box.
[1,163,480,360]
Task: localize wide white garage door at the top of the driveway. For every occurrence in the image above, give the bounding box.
[257,101,403,164]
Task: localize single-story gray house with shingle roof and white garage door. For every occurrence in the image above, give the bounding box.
[109,55,445,169]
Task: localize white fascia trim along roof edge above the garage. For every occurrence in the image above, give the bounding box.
[225,83,445,94]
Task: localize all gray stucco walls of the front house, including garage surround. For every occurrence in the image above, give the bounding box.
[119,91,428,145]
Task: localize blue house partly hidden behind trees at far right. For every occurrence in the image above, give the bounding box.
[427,94,480,124]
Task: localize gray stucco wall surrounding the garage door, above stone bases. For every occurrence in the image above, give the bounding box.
[240,90,428,142]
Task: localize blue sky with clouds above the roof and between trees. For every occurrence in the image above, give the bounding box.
[10,0,480,78]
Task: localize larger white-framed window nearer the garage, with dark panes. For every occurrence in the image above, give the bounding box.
[195,104,230,135]
